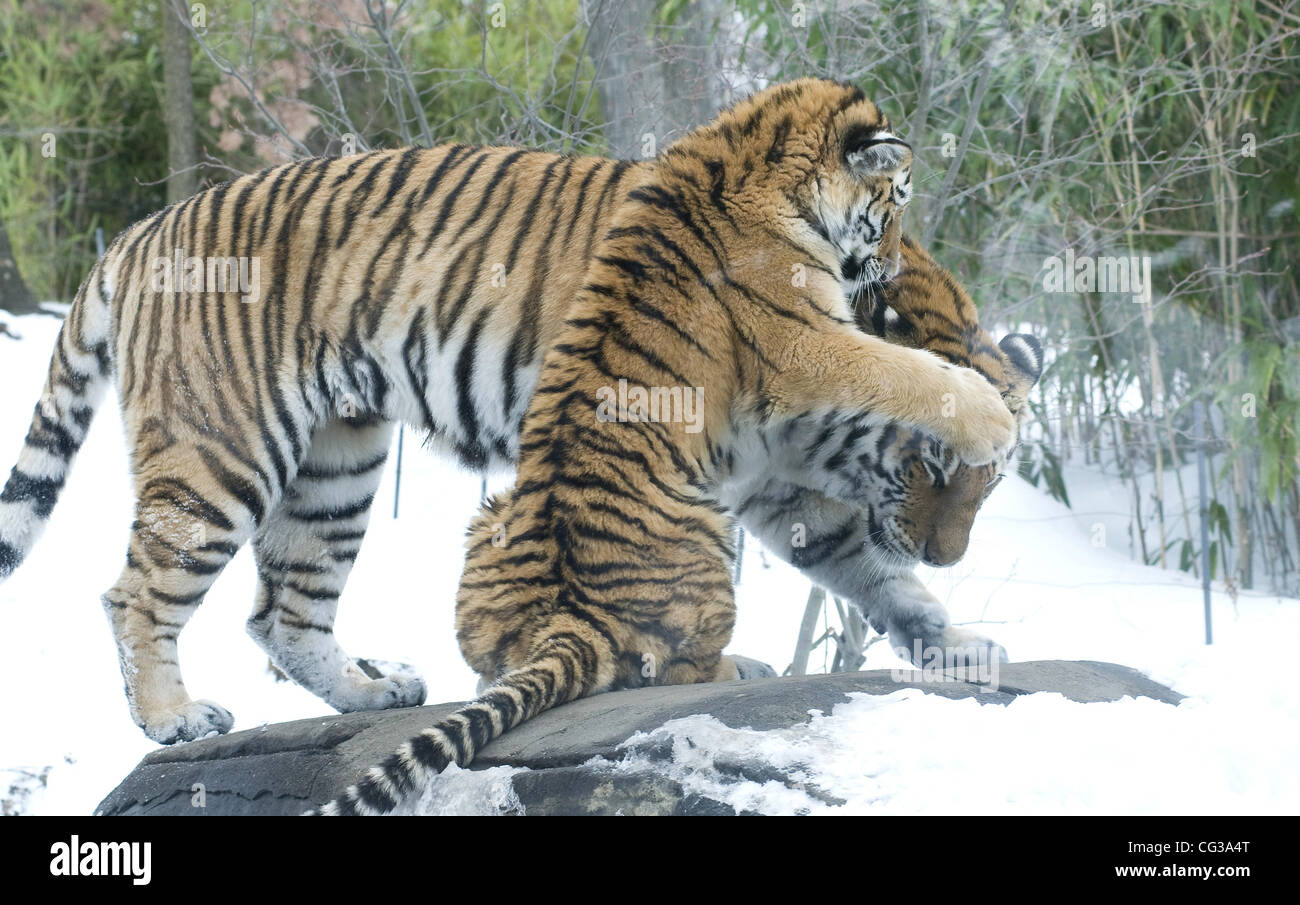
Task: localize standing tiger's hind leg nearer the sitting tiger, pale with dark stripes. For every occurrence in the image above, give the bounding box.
[247,420,425,713]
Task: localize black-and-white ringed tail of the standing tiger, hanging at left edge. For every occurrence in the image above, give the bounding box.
[0,261,112,581]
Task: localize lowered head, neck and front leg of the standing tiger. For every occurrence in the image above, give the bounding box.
[723,235,1043,668]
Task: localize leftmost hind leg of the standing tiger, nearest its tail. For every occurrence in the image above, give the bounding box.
[101,446,266,745]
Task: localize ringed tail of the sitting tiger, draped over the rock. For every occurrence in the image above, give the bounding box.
[308,635,593,817]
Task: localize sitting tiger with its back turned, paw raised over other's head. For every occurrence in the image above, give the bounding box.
[312,79,1032,815]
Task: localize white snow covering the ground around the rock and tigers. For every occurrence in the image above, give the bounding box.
[0,317,1300,814]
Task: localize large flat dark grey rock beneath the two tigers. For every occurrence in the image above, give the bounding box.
[98,661,1182,815]
